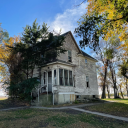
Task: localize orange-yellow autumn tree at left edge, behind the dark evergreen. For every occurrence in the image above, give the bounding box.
[0,36,20,94]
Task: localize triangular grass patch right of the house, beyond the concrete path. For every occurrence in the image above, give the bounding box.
[83,99,128,117]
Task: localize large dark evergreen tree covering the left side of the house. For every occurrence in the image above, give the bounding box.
[9,20,66,100]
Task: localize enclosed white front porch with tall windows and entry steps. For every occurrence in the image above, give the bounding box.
[31,67,75,105]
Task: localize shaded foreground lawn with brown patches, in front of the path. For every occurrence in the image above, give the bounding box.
[0,109,128,128]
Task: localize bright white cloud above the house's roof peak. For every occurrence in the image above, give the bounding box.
[48,3,87,33]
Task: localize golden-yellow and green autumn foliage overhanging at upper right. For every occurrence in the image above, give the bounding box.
[75,0,128,98]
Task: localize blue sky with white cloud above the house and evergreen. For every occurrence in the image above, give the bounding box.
[0,0,91,94]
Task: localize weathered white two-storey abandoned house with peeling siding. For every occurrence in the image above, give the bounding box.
[32,31,99,105]
